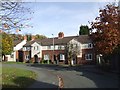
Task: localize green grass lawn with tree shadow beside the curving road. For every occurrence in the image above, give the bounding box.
[2,67,36,88]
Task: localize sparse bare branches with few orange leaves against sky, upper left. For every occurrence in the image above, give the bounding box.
[0,0,31,33]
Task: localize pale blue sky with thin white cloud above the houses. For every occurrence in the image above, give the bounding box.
[17,0,117,37]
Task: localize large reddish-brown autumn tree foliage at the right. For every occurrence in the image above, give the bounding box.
[91,3,120,55]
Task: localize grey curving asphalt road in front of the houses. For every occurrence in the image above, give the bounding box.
[2,64,119,88]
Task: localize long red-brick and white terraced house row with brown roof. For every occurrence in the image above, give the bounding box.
[21,32,95,64]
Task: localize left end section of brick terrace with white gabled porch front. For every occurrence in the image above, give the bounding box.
[19,40,42,62]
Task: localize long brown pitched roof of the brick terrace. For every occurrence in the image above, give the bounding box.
[24,35,92,46]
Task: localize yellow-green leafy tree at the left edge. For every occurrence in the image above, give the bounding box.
[2,33,13,55]
